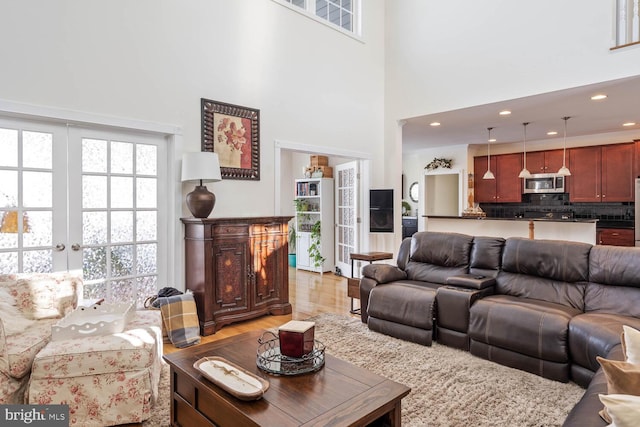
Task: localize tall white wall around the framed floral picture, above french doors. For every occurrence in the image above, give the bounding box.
[0,0,384,221]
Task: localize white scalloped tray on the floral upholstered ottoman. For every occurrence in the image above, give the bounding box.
[51,303,136,341]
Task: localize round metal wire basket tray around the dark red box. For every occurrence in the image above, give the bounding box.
[256,331,325,375]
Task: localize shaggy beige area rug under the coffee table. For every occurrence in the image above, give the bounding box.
[143,314,584,427]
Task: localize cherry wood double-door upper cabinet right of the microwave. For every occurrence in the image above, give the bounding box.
[568,143,635,202]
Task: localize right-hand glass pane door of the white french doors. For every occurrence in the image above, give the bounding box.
[69,128,166,306]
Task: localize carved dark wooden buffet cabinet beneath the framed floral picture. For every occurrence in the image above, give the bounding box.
[181,216,291,335]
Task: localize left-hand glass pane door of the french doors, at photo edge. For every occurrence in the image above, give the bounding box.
[0,120,67,274]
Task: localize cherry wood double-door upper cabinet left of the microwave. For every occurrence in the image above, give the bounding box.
[473,153,522,203]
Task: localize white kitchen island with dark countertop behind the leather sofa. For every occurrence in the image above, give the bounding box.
[423,215,598,245]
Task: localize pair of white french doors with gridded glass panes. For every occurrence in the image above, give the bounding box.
[0,118,167,305]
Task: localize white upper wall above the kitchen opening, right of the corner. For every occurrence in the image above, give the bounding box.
[385,0,640,120]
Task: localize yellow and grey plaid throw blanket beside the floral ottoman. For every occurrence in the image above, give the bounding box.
[157,293,200,348]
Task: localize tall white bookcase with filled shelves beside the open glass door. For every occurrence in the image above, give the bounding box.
[295,178,335,273]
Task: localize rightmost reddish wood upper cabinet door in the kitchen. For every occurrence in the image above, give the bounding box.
[602,143,635,202]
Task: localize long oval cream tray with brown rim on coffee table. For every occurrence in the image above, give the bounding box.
[193,356,269,400]
